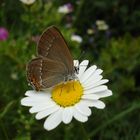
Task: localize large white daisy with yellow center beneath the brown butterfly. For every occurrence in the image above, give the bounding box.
[21,60,112,130]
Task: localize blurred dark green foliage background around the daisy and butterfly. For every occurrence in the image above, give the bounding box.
[0,0,140,140]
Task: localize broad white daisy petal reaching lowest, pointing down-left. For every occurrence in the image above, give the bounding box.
[44,108,63,130]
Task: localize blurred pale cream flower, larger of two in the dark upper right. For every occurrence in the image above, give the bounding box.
[96,20,109,30]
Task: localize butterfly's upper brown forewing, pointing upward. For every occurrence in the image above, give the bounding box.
[38,26,74,74]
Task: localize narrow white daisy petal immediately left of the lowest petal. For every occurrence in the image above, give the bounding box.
[35,105,60,120]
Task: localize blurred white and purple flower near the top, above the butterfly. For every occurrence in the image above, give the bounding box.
[58,3,73,14]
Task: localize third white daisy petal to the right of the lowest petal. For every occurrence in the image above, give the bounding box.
[75,102,91,116]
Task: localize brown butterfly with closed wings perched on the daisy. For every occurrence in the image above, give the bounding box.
[27,26,76,91]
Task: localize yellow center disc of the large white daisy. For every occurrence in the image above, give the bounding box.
[52,81,83,107]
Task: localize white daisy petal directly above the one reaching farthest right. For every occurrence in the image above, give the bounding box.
[84,85,107,94]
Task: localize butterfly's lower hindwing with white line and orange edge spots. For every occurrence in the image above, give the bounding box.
[27,57,66,91]
